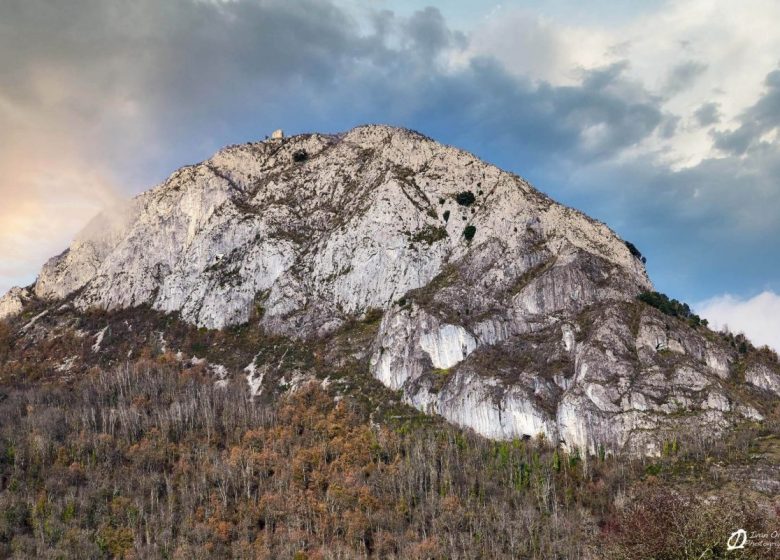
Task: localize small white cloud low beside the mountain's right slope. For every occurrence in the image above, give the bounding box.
[696,291,780,352]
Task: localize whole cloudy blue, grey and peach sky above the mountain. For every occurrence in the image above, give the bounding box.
[0,0,780,349]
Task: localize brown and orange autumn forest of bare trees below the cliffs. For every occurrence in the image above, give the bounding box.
[0,355,778,560]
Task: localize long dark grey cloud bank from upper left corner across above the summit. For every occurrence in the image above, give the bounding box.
[0,0,664,182]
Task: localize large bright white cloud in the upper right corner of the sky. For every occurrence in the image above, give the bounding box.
[460,0,780,169]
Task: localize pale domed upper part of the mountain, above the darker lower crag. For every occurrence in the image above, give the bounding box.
[29,126,650,333]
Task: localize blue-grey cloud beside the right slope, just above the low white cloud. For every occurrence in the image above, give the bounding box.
[560,119,780,301]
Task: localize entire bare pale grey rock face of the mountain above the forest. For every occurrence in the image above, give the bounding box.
[0,126,776,453]
